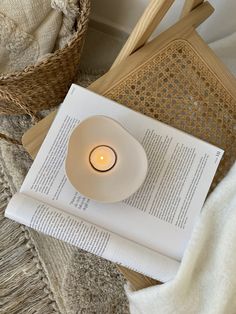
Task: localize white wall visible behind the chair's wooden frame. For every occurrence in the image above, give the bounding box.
[91,0,236,42]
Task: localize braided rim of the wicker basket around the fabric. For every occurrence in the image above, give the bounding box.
[0,0,90,83]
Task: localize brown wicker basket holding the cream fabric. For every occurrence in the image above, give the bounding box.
[0,0,90,117]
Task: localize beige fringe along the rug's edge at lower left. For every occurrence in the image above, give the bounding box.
[0,166,60,314]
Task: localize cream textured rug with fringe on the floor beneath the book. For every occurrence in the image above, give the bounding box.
[0,72,129,314]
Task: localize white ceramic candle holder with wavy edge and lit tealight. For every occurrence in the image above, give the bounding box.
[65,116,148,203]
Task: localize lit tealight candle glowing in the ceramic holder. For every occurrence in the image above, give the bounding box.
[89,145,117,172]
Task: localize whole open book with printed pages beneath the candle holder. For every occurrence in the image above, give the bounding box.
[5,85,223,282]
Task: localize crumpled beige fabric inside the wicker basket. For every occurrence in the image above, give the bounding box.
[0,0,79,75]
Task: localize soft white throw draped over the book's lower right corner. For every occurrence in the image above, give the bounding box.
[126,164,236,314]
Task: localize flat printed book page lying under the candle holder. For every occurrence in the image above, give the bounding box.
[18,85,223,261]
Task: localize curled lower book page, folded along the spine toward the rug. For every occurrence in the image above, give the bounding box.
[6,193,179,282]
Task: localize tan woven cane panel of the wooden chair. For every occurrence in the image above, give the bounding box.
[105,40,236,187]
